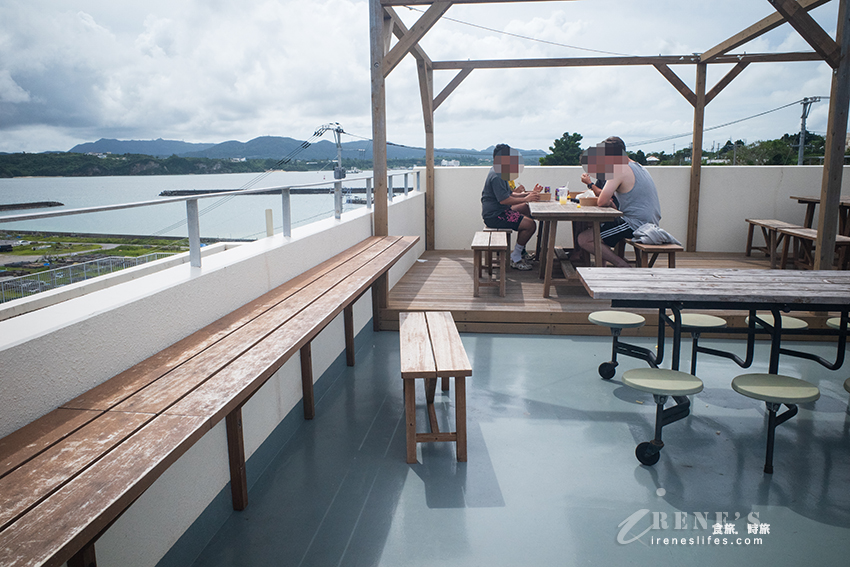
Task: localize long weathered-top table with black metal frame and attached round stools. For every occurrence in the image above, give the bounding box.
[578,268,850,374]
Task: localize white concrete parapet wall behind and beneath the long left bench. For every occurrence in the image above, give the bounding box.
[0,193,425,567]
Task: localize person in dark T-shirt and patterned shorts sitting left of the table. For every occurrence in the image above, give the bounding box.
[481,144,542,270]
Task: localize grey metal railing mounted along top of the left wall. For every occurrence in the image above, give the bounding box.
[0,171,421,268]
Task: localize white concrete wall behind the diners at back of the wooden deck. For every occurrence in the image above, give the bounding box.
[435,166,850,252]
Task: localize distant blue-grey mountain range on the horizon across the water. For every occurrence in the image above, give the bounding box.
[68,136,546,164]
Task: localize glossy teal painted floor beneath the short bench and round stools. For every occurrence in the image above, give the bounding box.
[189,332,850,567]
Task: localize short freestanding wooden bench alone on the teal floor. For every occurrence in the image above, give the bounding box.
[399,312,472,463]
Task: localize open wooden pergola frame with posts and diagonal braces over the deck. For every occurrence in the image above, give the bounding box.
[369,0,850,269]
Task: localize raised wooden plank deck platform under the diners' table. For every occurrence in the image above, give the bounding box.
[388,250,840,338]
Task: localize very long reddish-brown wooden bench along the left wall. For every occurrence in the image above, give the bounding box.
[0,237,418,567]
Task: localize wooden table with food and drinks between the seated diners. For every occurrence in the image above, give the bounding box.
[528,201,623,297]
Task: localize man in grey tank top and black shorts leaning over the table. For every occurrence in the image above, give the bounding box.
[577,136,661,268]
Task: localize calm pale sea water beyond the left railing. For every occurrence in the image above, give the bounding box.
[0,171,380,239]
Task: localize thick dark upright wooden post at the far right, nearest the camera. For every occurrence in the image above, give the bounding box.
[814,0,850,270]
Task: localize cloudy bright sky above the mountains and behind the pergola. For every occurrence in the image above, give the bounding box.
[0,0,838,153]
